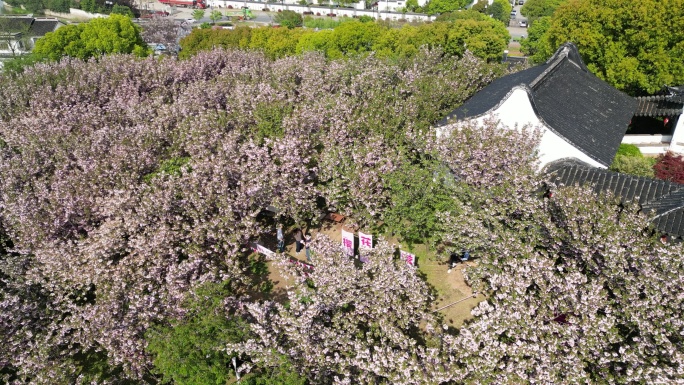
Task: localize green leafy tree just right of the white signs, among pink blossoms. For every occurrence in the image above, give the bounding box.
[383,161,455,246]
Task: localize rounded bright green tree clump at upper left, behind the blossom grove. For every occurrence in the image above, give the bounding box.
[33,15,150,61]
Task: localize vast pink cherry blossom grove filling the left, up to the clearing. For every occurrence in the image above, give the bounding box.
[0,51,500,383]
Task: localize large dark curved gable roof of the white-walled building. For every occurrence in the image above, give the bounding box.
[439,43,637,166]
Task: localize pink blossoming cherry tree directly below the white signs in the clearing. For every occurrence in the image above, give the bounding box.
[227,236,449,384]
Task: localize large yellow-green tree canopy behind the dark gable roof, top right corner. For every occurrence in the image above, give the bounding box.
[533,0,684,95]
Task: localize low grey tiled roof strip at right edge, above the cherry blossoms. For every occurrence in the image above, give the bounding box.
[544,159,684,237]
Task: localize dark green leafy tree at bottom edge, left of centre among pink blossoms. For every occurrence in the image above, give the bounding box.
[145,282,249,385]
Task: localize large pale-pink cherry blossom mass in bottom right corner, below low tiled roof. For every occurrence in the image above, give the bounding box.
[440,188,684,383]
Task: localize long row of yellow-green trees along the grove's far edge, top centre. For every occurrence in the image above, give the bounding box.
[180,17,510,61]
